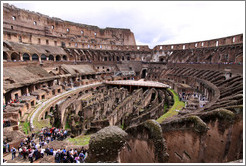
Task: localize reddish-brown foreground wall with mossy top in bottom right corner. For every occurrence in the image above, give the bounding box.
[161,110,243,163]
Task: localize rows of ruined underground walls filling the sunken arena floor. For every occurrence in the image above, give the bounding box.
[52,87,170,135]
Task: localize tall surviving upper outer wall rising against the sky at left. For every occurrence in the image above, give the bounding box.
[3,4,136,47]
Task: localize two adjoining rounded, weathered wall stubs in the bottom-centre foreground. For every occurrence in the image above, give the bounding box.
[86,120,168,163]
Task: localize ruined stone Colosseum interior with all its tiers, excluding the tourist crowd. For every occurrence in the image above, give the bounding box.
[2,3,244,163]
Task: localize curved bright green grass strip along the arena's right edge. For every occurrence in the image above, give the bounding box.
[156,89,185,123]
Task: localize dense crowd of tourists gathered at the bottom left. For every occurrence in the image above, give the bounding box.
[3,127,90,163]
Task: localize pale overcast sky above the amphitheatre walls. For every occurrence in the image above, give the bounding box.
[8,1,245,48]
